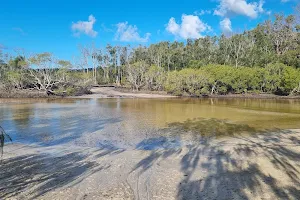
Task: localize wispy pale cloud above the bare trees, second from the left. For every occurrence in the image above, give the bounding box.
[115,22,151,42]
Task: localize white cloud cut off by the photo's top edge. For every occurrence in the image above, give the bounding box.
[214,0,264,19]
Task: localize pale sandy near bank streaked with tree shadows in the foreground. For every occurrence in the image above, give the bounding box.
[0,130,300,200]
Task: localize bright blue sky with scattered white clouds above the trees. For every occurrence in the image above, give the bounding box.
[0,0,299,59]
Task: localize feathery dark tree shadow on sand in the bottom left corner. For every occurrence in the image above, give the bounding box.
[0,152,110,199]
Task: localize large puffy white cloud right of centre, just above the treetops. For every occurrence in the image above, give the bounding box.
[166,14,212,39]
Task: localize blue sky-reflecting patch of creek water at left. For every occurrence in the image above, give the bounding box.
[0,100,120,145]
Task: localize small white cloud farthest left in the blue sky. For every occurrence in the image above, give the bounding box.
[71,15,98,37]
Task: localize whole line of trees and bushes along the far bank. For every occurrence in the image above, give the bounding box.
[0,9,300,96]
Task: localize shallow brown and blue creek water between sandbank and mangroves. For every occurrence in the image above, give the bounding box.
[0,99,300,150]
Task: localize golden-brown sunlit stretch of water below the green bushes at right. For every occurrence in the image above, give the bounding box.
[98,99,300,129]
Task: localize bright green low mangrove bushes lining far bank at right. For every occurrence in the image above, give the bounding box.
[165,63,300,96]
